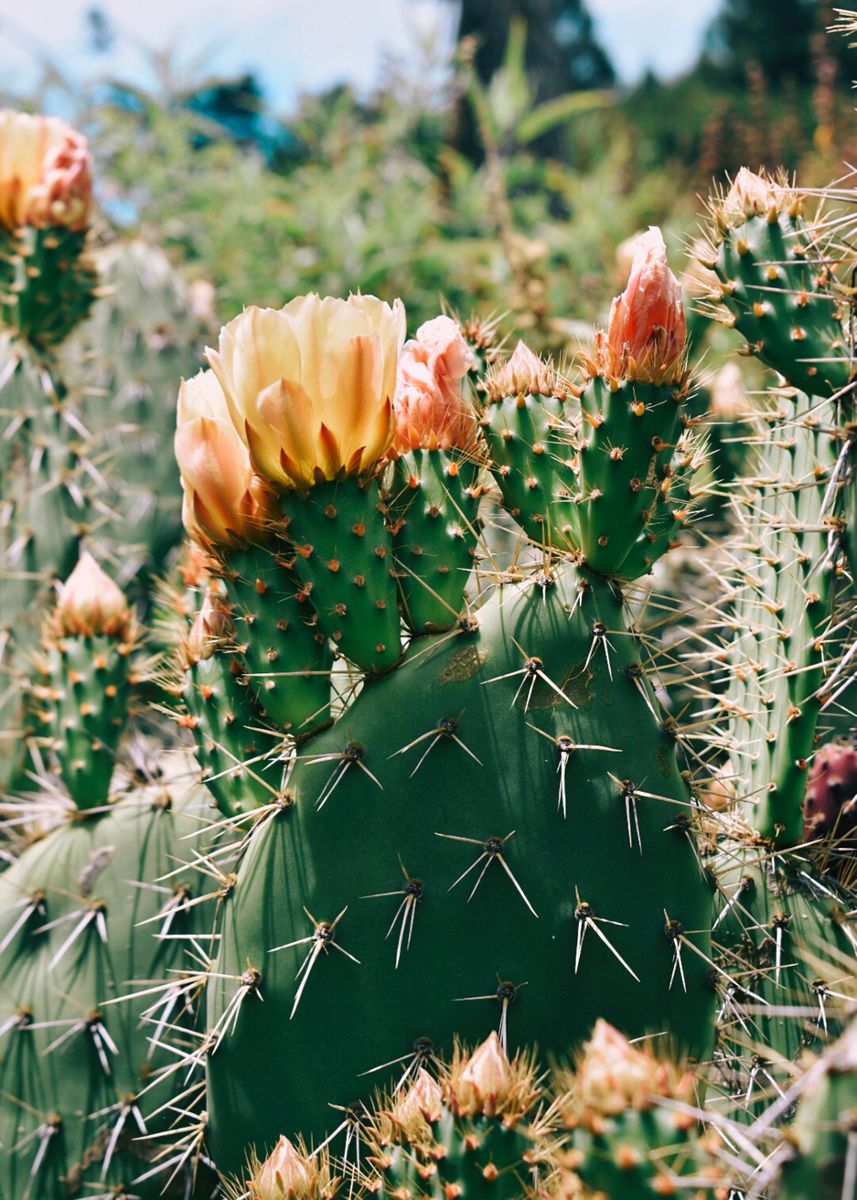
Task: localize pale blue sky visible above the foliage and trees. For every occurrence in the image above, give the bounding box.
[0,0,719,110]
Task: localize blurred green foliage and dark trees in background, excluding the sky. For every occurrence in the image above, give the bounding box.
[4,0,857,353]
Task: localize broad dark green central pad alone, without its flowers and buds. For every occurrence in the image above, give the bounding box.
[209,568,714,1171]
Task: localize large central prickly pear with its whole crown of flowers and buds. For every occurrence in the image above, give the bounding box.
[160,248,717,1172]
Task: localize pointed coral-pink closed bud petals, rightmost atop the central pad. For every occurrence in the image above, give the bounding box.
[595,226,688,383]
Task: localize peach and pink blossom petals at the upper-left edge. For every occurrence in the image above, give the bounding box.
[0,110,92,230]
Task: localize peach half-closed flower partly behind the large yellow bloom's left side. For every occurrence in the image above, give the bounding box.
[175,371,274,545]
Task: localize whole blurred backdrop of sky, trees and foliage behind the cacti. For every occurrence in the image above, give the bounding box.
[0,0,857,353]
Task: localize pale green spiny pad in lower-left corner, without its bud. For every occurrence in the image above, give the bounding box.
[0,764,214,1200]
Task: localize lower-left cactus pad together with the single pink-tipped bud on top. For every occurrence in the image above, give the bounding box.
[0,557,217,1200]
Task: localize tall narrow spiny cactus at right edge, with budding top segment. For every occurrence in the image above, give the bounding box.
[691,172,856,1112]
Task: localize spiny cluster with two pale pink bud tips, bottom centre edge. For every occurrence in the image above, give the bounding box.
[361,1033,552,1200]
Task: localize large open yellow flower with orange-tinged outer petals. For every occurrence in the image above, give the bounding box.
[209,294,404,490]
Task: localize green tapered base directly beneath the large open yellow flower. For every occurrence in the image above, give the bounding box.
[281,479,401,673]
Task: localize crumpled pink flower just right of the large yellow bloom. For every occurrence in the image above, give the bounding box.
[392,317,477,454]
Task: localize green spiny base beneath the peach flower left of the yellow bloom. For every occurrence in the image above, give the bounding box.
[223,546,332,734]
